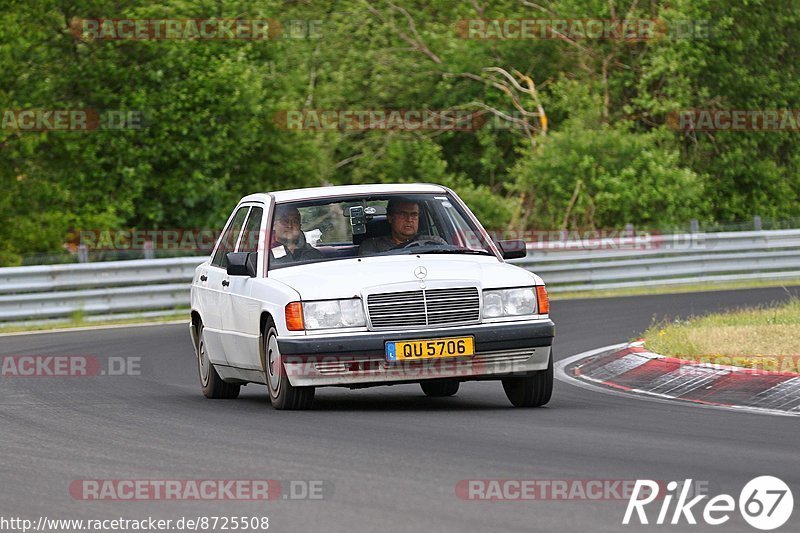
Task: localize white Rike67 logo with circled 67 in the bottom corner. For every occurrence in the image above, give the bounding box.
[622,476,794,531]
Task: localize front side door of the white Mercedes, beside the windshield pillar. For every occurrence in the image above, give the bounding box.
[221,205,265,370]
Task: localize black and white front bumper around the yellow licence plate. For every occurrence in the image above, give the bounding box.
[278,319,555,387]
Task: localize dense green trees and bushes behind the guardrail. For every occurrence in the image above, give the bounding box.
[0,0,800,265]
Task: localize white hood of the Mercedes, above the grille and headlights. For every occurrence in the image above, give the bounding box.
[269,254,542,300]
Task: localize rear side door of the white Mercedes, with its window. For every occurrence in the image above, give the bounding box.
[200,206,250,364]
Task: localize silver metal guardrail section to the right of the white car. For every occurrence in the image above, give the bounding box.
[512,230,800,292]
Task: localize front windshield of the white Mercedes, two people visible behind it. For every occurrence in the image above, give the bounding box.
[269,193,493,270]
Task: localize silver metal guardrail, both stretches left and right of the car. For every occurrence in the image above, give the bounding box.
[0,230,800,323]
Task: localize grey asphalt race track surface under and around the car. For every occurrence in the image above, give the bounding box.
[0,289,800,532]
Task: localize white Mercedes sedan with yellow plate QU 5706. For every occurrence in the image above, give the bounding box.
[190,184,555,409]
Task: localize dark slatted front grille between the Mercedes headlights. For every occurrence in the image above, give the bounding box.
[367,287,480,328]
